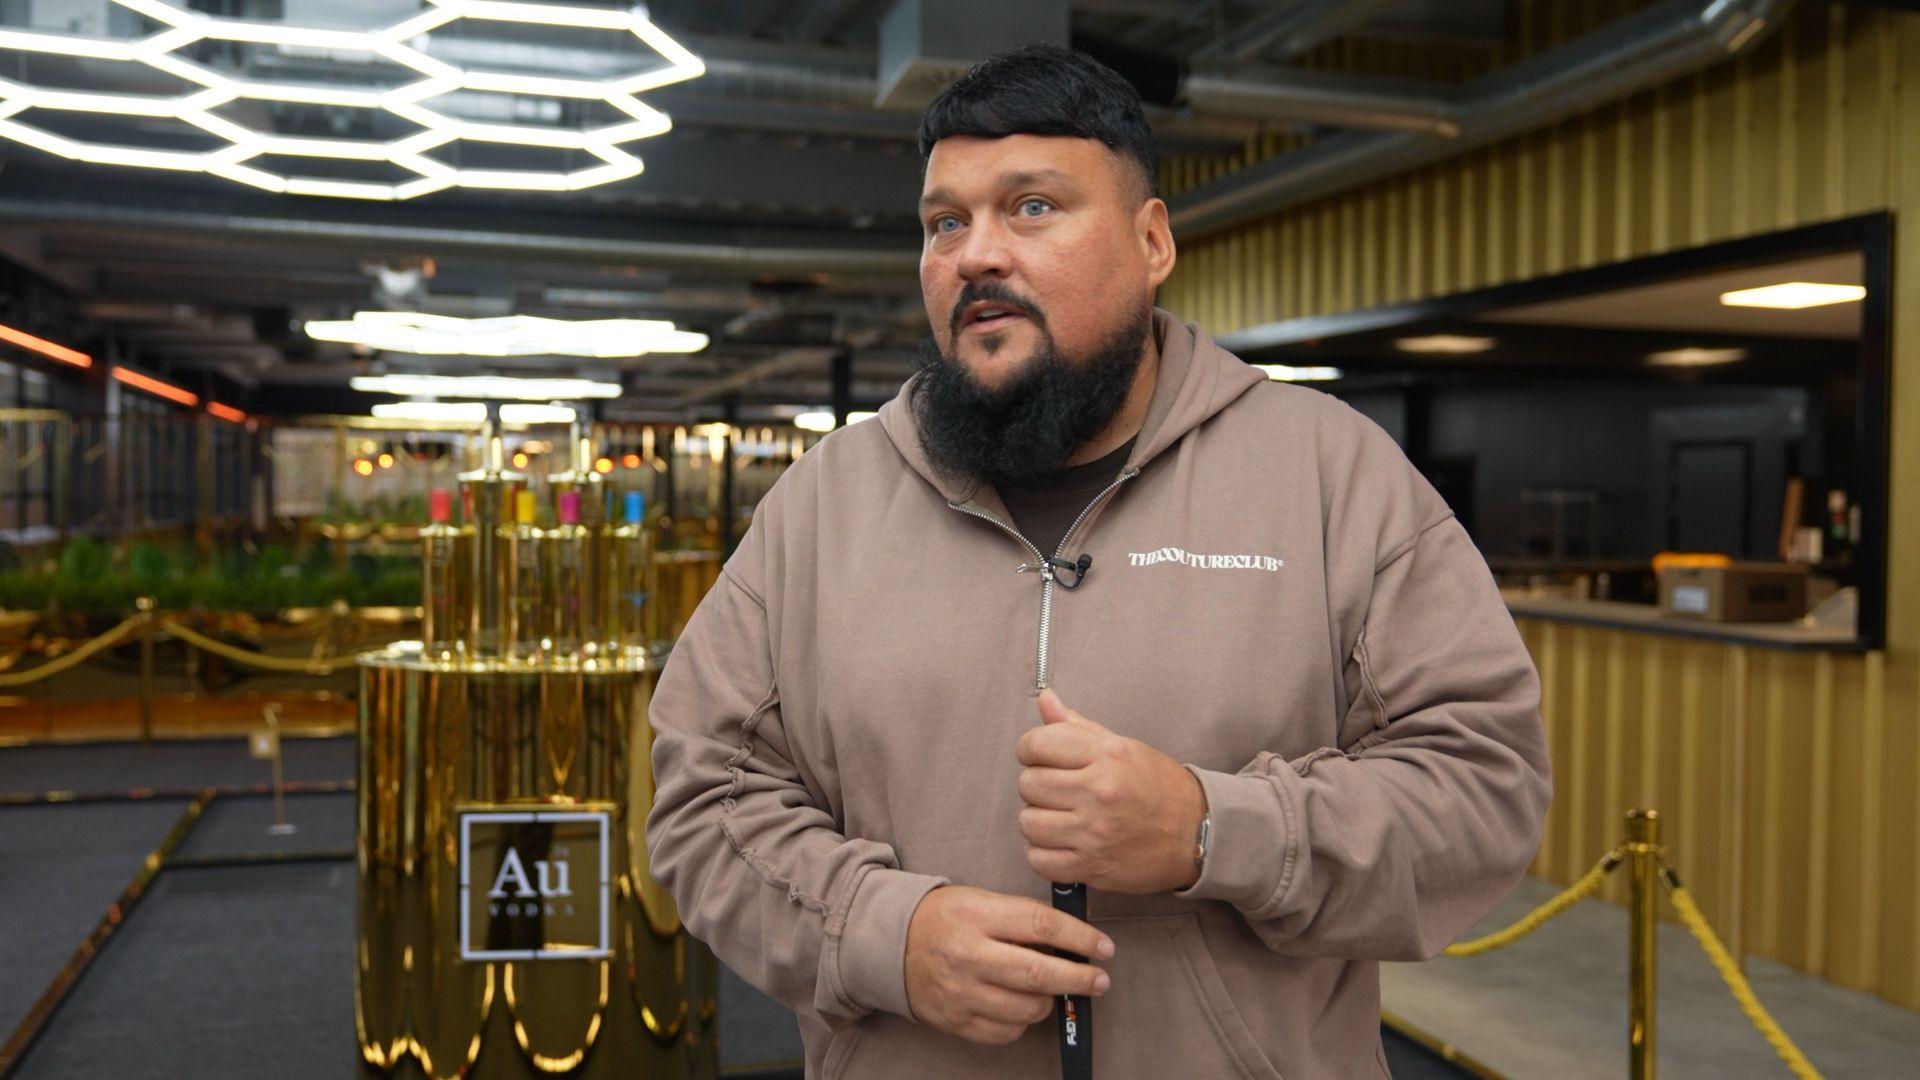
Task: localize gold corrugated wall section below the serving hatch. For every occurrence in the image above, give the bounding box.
[1519,617,1920,1005]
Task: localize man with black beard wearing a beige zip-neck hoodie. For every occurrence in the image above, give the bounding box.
[647,46,1548,1080]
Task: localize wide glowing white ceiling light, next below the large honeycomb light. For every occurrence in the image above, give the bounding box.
[307,311,707,357]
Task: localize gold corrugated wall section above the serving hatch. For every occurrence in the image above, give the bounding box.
[1162,6,1910,311]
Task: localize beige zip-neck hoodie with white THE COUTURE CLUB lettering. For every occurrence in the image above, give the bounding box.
[647,311,1549,1080]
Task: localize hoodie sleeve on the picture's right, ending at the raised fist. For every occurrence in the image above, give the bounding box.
[1177,405,1549,961]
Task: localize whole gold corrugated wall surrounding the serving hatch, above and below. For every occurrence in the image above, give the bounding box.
[1162,0,1920,1009]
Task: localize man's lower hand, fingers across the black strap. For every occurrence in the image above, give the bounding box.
[906,886,1114,1045]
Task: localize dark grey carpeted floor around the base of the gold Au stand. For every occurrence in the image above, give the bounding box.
[0,738,1461,1080]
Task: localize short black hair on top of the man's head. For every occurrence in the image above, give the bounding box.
[920,44,1160,198]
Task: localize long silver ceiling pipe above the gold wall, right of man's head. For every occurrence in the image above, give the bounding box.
[1169,0,1793,240]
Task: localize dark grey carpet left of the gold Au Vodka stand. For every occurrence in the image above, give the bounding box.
[0,776,801,1080]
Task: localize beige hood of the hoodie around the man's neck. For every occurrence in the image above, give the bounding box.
[879,307,1267,503]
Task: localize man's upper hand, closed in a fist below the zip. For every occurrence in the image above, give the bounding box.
[1018,690,1206,894]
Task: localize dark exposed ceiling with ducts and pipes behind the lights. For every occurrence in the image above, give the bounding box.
[0,0,1797,421]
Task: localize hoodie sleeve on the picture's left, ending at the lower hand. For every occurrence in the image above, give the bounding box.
[647,518,947,1026]
